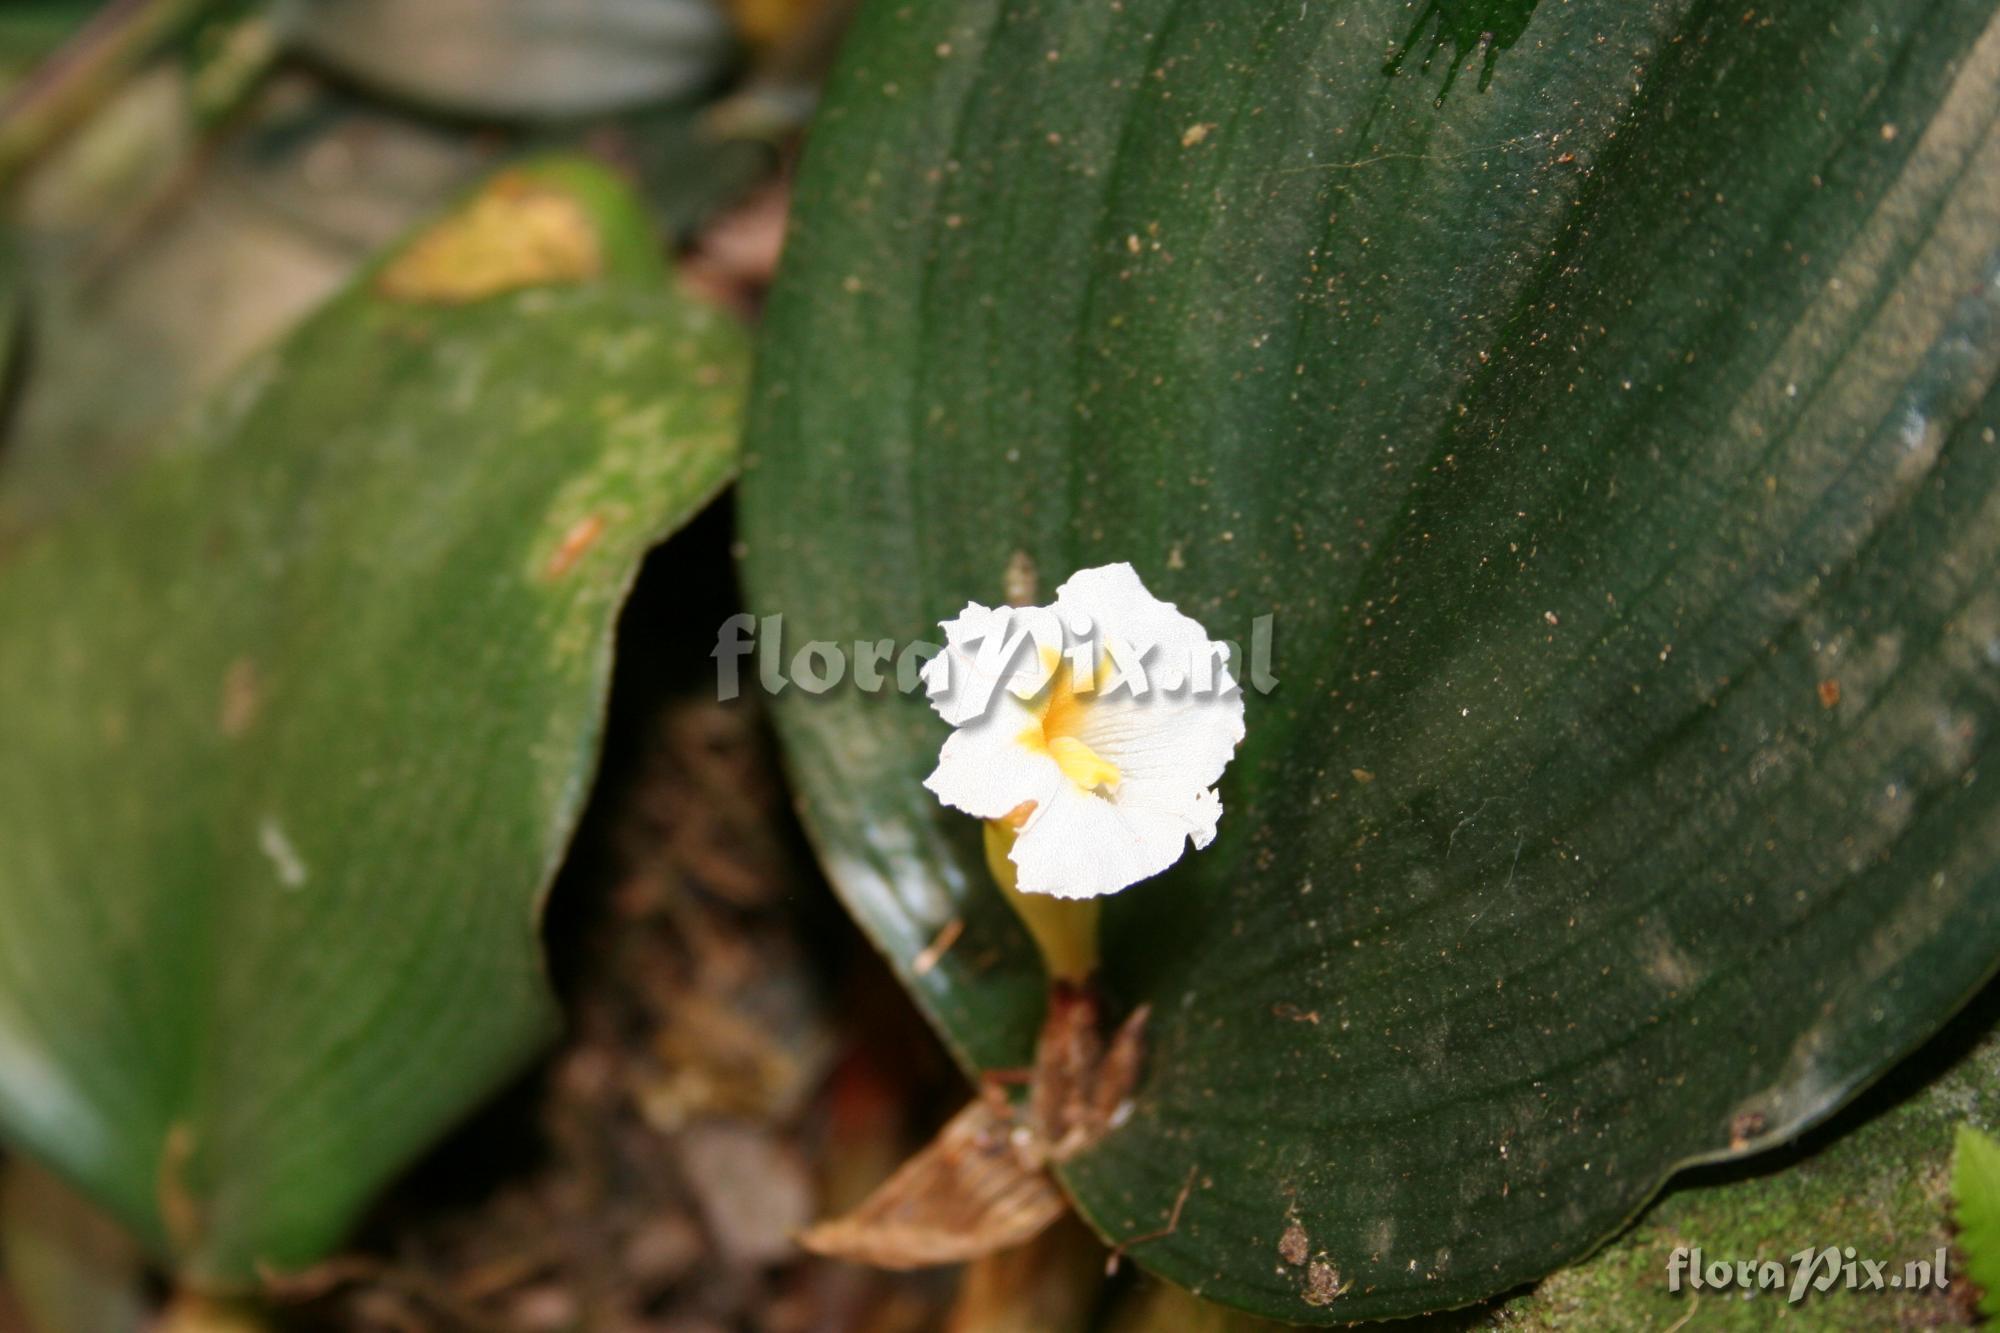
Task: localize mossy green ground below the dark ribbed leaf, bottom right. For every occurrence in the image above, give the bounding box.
[1106,987,2000,1333]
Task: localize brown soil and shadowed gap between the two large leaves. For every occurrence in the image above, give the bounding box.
[290,504,968,1333]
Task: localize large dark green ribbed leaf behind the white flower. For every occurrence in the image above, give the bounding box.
[744,0,2000,1321]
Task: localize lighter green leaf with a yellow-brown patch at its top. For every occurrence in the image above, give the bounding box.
[0,156,744,1281]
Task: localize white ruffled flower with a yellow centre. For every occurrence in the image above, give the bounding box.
[924,564,1244,899]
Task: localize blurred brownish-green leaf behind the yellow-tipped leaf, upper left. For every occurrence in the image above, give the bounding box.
[0,85,514,546]
